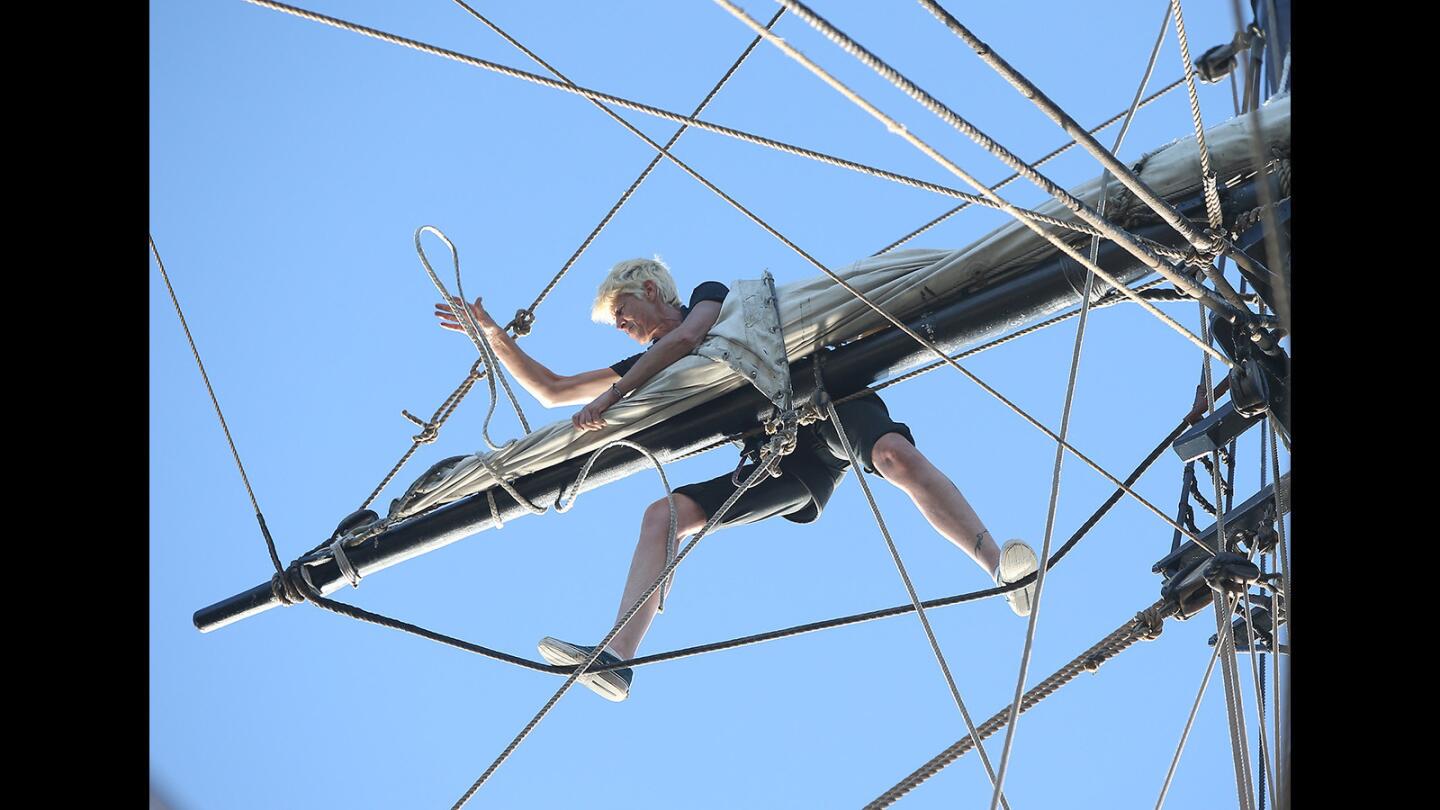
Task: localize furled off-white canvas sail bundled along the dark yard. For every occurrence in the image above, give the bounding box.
[390,95,1290,519]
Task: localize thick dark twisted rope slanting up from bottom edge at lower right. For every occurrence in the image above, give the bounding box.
[865,600,1175,810]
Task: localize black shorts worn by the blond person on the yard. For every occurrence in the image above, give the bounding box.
[675,393,914,528]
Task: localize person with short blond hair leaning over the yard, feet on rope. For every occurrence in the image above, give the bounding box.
[435,259,1037,700]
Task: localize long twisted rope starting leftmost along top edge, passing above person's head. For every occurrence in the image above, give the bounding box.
[246,0,1083,239]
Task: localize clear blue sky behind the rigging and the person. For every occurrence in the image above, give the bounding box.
[148,0,1290,809]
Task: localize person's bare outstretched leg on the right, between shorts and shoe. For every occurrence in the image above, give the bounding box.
[870,432,999,575]
